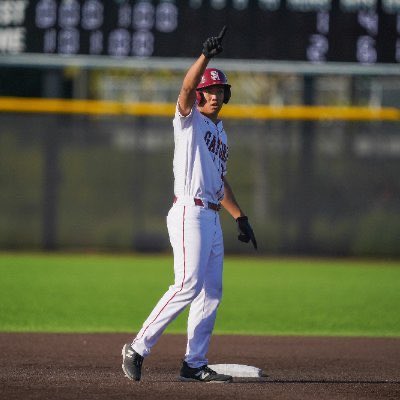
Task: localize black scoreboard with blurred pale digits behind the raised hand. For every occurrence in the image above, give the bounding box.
[0,0,400,64]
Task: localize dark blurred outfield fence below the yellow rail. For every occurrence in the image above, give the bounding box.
[0,114,400,257]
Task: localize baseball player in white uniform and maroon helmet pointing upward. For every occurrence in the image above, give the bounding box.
[122,27,257,382]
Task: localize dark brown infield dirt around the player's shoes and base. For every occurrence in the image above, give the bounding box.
[0,333,400,400]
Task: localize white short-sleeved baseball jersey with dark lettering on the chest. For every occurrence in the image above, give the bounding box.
[173,105,228,203]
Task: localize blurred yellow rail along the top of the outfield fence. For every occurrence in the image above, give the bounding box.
[0,97,400,121]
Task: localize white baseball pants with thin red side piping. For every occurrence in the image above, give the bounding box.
[132,201,224,368]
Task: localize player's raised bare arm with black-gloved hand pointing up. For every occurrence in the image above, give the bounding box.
[178,26,226,116]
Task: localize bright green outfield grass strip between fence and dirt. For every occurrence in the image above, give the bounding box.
[0,253,400,336]
